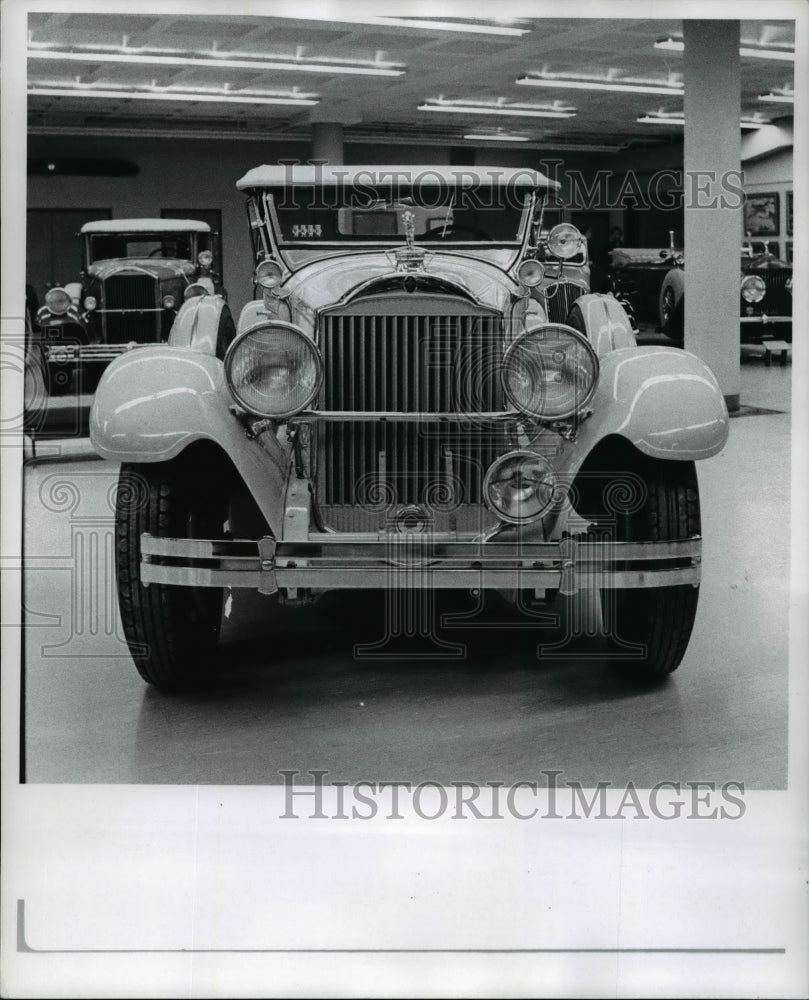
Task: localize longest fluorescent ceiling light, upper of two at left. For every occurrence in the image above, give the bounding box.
[28,49,405,76]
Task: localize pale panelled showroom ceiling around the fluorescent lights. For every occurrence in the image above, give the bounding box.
[29,13,794,151]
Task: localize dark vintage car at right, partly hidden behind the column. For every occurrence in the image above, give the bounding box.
[610,246,792,344]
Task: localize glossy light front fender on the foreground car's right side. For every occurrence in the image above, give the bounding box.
[565,347,729,471]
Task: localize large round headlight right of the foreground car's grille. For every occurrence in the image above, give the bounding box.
[502,323,598,420]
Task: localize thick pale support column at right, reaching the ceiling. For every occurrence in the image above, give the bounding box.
[683,19,742,410]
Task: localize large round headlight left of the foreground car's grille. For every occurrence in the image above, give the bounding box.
[225,320,323,419]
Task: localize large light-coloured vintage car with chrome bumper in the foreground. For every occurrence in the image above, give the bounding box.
[90,164,728,688]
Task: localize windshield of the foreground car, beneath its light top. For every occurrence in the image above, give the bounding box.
[258,184,531,246]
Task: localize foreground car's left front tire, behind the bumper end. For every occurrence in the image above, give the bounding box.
[115,456,227,690]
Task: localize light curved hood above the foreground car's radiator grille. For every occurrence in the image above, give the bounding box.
[282,250,519,315]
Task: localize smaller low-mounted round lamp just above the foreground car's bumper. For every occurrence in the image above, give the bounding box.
[483,451,559,524]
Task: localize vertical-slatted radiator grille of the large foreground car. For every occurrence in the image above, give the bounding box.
[317,315,508,531]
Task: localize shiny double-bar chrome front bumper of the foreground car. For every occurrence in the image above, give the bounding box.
[141,533,702,594]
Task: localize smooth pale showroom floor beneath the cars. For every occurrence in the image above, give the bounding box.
[24,358,792,789]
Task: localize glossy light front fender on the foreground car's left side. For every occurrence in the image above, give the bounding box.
[90,345,289,533]
